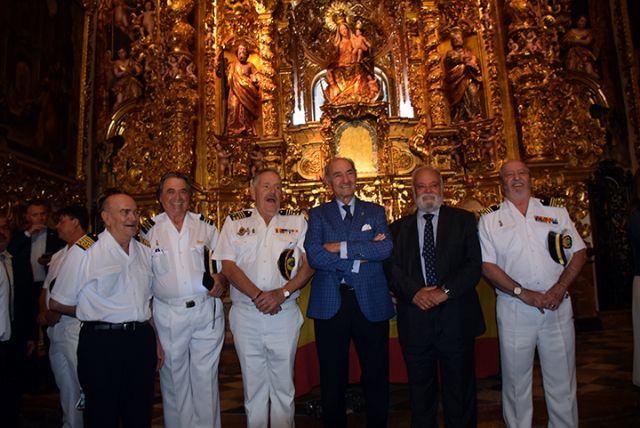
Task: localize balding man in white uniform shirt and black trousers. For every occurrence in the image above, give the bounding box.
[50,191,162,427]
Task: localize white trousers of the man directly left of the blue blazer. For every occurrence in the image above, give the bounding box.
[229,301,303,428]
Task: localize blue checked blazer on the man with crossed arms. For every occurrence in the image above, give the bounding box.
[304,199,394,322]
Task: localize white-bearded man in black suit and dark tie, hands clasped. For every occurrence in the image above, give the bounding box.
[385,166,484,428]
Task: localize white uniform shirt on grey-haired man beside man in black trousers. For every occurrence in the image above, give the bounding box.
[144,212,218,300]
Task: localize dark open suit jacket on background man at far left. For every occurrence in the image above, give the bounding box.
[7,228,65,340]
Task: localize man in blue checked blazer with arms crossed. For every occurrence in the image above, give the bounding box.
[304,158,394,428]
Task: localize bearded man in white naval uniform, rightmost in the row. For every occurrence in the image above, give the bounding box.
[479,160,586,428]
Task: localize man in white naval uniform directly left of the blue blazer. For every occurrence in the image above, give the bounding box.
[214,169,313,428]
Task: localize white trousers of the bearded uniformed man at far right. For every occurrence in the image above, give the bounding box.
[496,295,578,428]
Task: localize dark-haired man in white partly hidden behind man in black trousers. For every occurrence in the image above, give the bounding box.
[38,205,90,428]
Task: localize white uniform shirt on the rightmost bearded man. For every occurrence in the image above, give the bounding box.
[478,198,585,294]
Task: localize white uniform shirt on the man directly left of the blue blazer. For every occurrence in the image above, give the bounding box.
[213,209,307,305]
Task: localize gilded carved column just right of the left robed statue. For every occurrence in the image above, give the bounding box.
[256,1,278,137]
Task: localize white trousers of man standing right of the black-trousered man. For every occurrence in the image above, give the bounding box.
[153,296,224,428]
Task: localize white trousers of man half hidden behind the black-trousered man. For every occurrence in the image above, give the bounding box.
[47,315,84,428]
